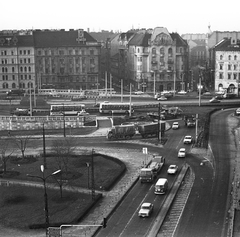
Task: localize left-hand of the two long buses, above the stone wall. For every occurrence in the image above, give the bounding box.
[50,104,87,116]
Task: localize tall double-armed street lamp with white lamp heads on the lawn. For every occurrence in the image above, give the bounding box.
[27,165,61,236]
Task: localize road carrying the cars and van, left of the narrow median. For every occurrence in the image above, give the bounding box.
[97,121,195,237]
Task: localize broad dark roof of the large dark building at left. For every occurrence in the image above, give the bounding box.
[33,30,97,47]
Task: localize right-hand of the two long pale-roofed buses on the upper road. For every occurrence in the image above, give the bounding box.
[99,101,134,114]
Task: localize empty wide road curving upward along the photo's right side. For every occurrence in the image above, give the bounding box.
[175,110,236,237]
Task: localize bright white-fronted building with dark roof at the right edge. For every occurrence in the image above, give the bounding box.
[211,38,240,95]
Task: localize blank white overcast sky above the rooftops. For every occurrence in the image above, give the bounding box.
[0,0,240,35]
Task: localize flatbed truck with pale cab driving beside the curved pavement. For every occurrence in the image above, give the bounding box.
[139,156,165,183]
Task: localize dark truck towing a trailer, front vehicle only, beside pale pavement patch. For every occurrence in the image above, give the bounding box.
[107,124,136,140]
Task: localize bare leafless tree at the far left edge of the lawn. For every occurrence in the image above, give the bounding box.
[0,138,14,174]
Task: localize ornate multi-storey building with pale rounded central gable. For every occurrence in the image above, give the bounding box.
[128,27,189,92]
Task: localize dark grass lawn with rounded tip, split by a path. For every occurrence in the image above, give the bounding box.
[0,154,125,228]
